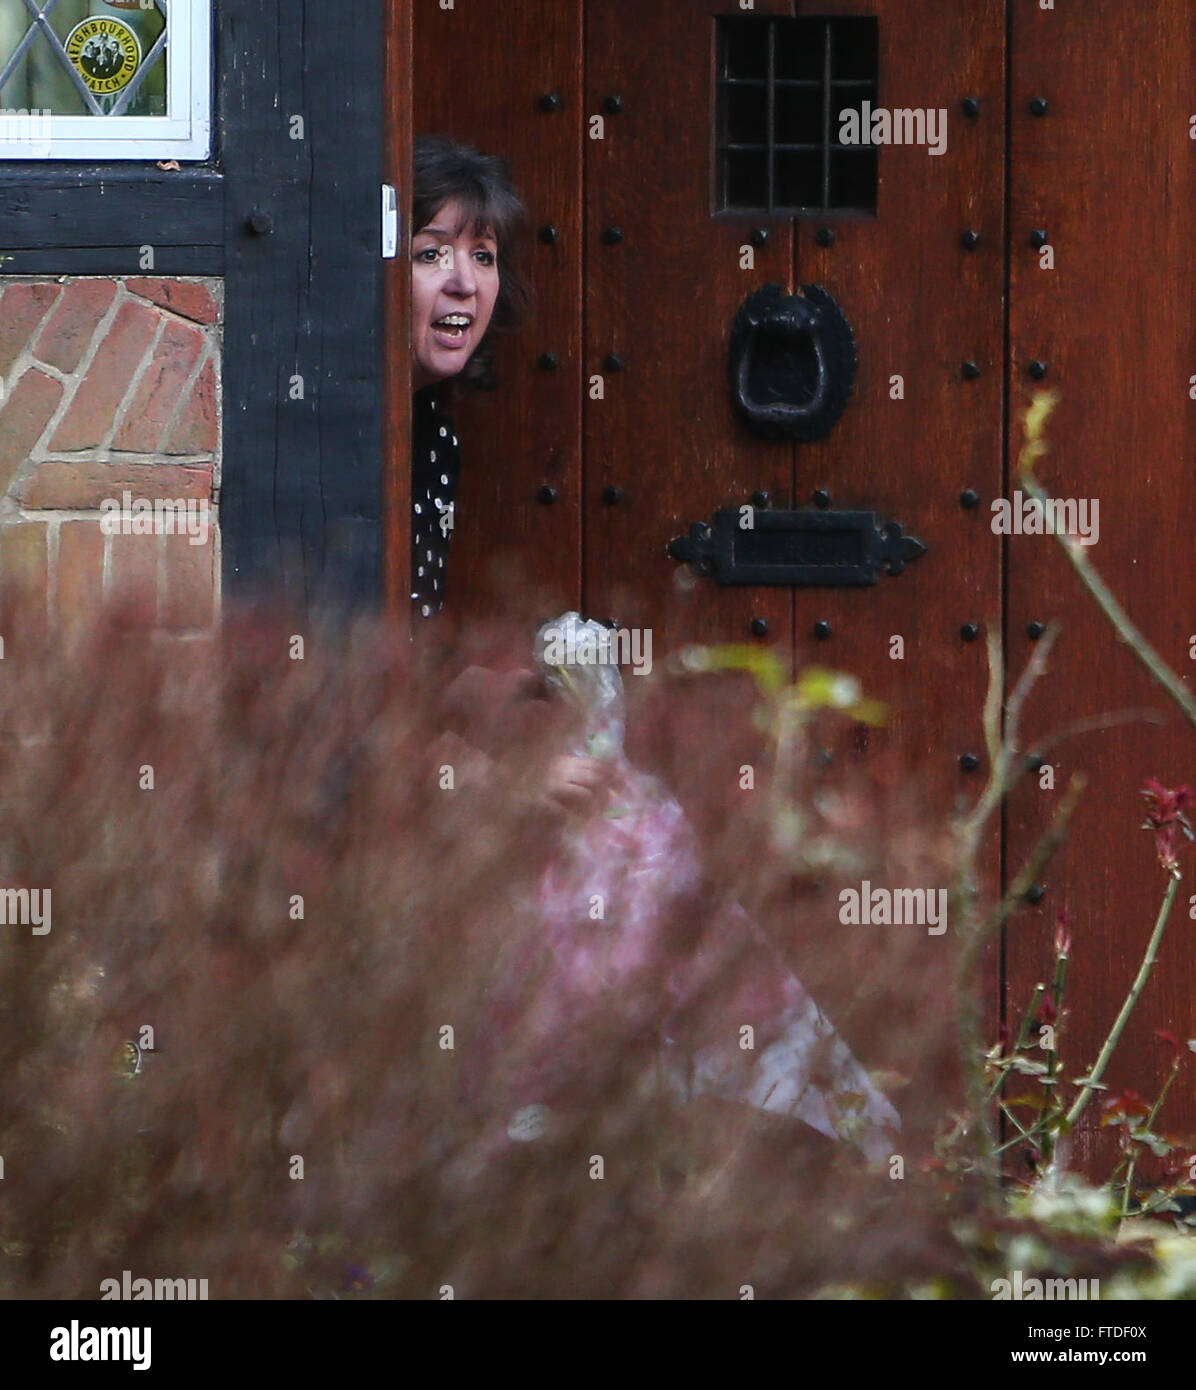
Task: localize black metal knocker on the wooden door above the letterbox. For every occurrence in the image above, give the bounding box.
[730,285,855,443]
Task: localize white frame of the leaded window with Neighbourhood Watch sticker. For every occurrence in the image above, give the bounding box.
[0,0,211,163]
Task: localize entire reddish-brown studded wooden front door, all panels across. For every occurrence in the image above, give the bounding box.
[414,0,1196,1162]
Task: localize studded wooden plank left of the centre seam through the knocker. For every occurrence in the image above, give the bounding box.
[584,0,793,648]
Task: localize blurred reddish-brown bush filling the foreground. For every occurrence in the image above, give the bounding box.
[0,597,975,1298]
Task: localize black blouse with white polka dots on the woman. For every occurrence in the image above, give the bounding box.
[412,385,460,617]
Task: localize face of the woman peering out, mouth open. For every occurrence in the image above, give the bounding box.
[412,199,498,391]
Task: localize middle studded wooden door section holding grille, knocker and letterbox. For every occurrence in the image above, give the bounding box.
[584,0,1005,1073]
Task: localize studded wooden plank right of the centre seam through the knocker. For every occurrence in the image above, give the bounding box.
[794,0,1004,798]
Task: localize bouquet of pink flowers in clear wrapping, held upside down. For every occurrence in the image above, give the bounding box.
[472,613,901,1162]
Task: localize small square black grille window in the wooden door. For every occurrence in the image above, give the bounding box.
[715,15,878,214]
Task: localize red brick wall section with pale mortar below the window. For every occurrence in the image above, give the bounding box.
[0,277,223,632]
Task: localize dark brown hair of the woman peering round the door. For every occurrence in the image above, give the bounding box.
[412,135,531,391]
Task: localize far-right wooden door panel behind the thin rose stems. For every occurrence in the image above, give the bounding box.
[1007,0,1196,1158]
